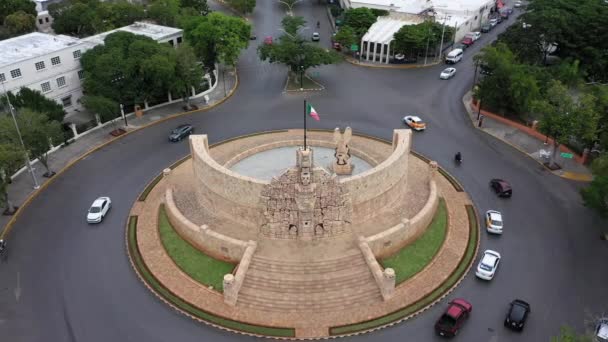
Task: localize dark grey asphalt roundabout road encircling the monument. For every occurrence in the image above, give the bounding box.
[0,1,608,342]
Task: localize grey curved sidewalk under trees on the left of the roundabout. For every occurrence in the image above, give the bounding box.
[0,67,238,238]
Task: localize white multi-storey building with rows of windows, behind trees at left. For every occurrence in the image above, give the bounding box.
[0,23,183,119]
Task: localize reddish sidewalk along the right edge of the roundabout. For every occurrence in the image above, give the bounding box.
[462,92,592,181]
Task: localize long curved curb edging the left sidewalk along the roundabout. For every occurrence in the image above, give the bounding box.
[0,69,239,240]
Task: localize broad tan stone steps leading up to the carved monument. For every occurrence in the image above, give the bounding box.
[237,249,382,312]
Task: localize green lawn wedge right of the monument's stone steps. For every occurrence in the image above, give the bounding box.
[380,198,448,284]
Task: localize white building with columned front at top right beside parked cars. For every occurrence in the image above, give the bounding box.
[340,0,495,63]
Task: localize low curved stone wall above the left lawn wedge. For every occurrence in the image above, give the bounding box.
[165,188,248,263]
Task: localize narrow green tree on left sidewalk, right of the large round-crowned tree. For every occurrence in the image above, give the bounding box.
[172,43,204,108]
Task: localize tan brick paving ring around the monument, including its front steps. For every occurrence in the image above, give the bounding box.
[133,136,471,338]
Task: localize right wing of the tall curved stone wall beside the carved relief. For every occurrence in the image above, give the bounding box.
[340,129,412,222]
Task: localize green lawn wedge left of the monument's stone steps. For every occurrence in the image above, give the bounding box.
[158,205,235,292]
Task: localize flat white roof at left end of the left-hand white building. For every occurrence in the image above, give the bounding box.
[0,32,80,68]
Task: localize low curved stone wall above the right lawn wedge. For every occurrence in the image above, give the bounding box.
[365,180,439,258]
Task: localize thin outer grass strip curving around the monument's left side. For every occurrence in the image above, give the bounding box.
[128,216,295,337]
